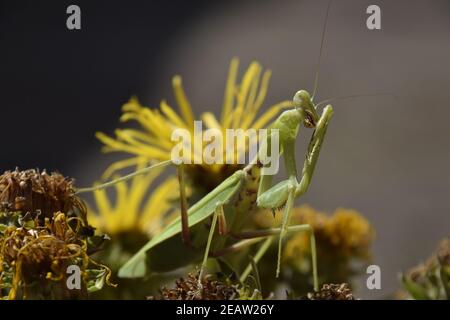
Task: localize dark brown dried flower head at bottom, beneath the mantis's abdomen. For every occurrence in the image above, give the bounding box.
[148,273,239,300]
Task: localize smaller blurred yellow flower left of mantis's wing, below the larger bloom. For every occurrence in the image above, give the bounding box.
[89,158,179,237]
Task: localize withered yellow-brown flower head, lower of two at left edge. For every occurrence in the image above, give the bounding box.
[0,212,110,299]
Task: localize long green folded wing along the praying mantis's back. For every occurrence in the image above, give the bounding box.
[118,170,245,278]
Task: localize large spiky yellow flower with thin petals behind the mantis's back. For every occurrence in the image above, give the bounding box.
[96,59,293,188]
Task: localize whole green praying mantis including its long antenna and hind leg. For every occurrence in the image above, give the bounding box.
[78,1,344,291]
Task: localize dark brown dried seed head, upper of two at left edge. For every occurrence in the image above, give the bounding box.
[0,169,86,218]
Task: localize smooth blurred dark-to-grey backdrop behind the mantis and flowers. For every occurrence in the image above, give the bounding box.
[0,0,450,299]
